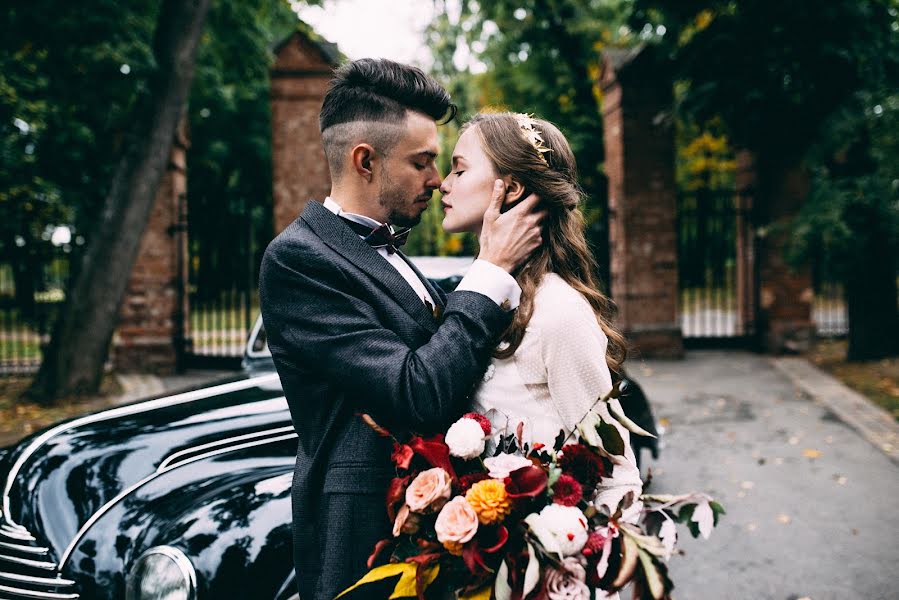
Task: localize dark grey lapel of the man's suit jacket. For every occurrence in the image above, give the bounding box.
[301,201,439,333]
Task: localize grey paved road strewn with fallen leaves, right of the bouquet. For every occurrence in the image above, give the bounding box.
[628,351,899,600]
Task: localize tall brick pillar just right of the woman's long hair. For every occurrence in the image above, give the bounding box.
[602,47,683,357]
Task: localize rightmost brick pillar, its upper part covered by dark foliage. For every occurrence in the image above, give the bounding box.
[756,156,815,354]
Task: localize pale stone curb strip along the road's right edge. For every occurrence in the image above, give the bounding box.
[771,357,899,465]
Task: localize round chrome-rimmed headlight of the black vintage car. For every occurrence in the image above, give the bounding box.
[125,546,197,600]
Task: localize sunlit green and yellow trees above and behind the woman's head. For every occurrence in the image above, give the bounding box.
[427,0,633,274]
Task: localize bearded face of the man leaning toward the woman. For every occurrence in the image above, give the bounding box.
[378,111,441,227]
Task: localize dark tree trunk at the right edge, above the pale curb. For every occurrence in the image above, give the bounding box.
[844,203,899,360]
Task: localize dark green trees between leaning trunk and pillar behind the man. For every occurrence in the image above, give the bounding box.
[187,1,299,296]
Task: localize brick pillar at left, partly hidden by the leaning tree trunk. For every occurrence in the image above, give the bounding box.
[113,120,188,374]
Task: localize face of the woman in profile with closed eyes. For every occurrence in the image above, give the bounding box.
[440,127,497,234]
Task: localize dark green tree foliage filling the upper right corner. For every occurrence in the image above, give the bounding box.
[631,0,899,358]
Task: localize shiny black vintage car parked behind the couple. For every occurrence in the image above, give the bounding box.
[0,261,645,600]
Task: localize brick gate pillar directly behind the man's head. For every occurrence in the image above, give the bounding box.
[271,32,340,235]
